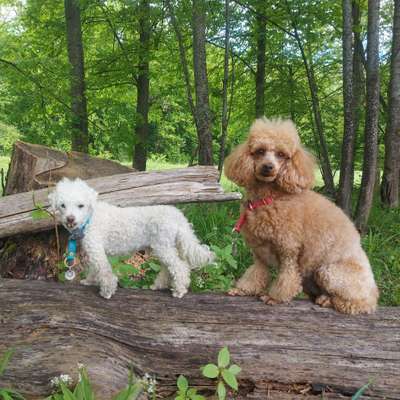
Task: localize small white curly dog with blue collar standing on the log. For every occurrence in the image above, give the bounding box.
[49,178,214,299]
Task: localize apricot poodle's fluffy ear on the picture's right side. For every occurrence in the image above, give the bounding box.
[276,147,315,193]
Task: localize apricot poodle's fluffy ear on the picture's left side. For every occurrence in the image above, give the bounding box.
[224,142,254,187]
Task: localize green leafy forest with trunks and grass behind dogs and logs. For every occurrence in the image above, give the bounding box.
[0,0,400,305]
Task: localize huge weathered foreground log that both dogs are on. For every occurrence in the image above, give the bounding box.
[0,279,400,400]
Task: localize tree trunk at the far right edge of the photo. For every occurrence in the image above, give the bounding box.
[381,0,400,207]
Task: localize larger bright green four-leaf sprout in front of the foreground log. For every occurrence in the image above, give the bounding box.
[202,347,241,400]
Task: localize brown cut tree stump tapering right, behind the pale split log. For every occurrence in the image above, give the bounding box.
[4,141,134,195]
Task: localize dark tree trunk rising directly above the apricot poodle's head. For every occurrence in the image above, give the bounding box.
[255,0,267,118]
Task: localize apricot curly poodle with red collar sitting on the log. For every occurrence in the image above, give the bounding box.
[225,118,378,314]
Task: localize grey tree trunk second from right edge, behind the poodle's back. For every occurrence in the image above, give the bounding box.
[356,0,380,231]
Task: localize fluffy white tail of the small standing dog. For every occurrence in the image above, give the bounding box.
[176,225,215,269]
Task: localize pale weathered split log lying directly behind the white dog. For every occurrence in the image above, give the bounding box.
[0,166,241,238]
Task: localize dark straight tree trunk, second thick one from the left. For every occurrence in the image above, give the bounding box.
[133,0,150,171]
